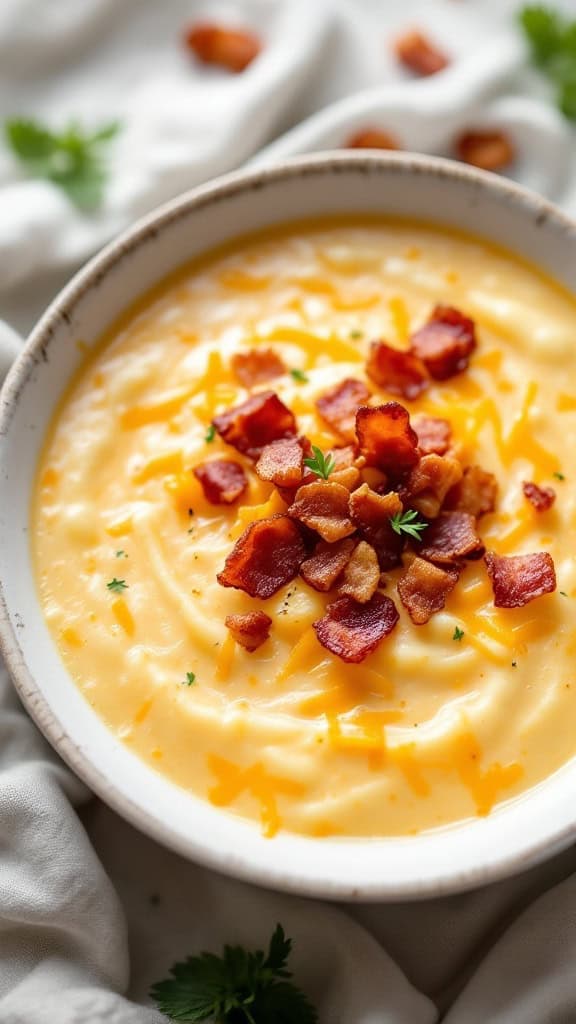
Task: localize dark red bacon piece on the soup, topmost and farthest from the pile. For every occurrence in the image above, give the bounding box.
[410,306,476,381]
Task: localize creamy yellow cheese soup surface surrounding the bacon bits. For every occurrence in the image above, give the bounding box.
[32,219,576,837]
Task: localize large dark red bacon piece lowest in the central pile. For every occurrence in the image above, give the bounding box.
[313,591,400,665]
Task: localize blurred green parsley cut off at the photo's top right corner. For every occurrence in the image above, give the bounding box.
[520,4,576,120]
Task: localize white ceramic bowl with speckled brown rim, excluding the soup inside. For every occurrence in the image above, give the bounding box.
[0,153,576,900]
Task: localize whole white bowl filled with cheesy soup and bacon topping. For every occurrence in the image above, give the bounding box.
[0,154,576,900]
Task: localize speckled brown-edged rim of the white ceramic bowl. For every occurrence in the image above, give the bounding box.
[0,151,576,902]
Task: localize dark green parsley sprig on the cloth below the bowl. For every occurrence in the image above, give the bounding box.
[150,925,318,1024]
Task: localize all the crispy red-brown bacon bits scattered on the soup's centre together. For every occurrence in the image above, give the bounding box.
[194,305,556,663]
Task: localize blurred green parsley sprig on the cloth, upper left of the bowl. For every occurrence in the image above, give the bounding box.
[4,118,120,210]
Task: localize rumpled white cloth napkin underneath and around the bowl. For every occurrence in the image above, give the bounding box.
[0,0,576,1024]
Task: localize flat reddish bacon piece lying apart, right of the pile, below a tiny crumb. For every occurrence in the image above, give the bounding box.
[485,551,556,608]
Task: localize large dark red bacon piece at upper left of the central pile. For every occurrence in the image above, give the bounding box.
[212,391,296,459]
